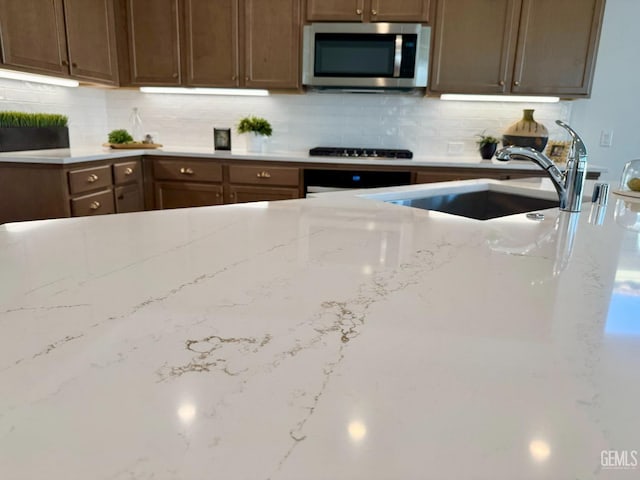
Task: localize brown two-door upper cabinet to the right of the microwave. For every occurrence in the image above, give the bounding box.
[429,0,604,97]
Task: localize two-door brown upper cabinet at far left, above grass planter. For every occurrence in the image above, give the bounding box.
[0,0,118,85]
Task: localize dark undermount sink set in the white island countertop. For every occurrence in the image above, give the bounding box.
[384,189,559,220]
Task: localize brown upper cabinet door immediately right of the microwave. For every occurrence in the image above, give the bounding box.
[430,0,520,93]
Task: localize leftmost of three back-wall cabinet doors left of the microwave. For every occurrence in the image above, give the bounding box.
[127,0,181,85]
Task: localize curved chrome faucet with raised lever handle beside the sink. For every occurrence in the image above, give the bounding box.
[496,120,587,212]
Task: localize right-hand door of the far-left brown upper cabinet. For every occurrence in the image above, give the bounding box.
[64,0,118,84]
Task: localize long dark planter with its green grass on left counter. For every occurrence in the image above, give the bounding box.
[0,111,69,152]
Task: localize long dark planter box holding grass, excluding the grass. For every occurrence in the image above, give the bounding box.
[0,127,69,152]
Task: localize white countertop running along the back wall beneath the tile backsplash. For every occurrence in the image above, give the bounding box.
[0,146,607,173]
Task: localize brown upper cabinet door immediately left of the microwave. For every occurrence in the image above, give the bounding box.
[244,0,301,88]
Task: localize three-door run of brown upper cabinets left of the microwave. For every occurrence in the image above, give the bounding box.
[127,0,301,89]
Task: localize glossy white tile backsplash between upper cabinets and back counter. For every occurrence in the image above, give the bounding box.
[0,80,572,158]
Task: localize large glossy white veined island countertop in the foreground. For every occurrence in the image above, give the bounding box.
[0,181,640,480]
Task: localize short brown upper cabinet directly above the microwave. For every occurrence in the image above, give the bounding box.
[307,0,431,23]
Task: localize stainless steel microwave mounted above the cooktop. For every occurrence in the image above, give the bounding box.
[302,23,431,89]
